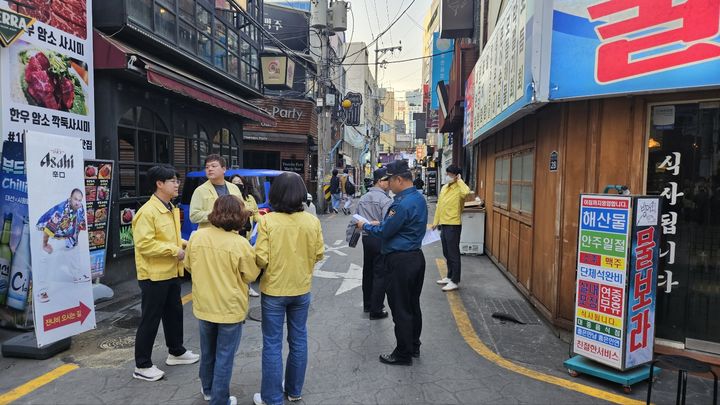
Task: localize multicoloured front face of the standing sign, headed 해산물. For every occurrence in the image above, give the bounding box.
[573,195,632,369]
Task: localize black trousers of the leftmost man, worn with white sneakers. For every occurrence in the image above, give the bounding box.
[135,278,185,368]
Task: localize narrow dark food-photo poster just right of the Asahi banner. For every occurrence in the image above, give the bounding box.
[85,160,113,279]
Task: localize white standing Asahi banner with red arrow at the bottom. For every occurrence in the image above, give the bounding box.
[25,132,95,346]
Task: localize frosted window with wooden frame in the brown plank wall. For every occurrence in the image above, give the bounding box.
[493,150,535,215]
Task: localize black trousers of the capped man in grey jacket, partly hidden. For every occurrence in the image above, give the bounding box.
[362,236,385,314]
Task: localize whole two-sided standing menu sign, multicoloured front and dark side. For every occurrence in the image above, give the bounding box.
[573,194,661,370]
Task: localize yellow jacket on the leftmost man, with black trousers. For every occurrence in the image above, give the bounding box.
[132,195,186,281]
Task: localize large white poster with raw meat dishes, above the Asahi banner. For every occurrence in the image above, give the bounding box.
[0,0,95,159]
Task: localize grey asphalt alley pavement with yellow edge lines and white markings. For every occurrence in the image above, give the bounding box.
[0,210,712,404]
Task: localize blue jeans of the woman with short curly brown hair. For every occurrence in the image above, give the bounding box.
[200,320,242,405]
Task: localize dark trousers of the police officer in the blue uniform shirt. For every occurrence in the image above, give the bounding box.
[384,250,425,360]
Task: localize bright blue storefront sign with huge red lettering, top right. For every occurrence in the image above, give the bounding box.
[550,0,720,100]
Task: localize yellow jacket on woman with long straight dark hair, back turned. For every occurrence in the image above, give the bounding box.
[255,212,325,297]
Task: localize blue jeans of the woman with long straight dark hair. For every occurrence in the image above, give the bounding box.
[260,293,310,405]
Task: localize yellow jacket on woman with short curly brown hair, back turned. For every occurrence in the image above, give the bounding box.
[185,225,260,323]
